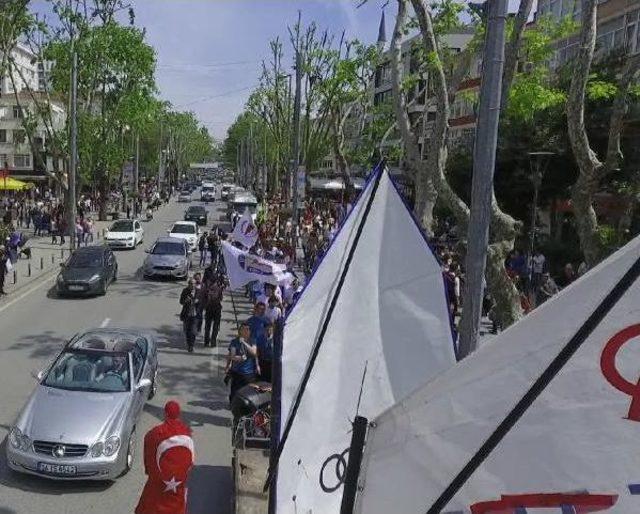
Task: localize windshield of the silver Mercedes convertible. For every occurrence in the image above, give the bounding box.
[43,350,131,393]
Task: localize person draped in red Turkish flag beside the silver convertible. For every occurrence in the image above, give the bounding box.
[135,401,195,514]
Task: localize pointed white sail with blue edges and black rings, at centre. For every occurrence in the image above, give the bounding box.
[277,166,455,514]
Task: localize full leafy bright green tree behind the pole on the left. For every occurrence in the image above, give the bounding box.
[46,19,156,219]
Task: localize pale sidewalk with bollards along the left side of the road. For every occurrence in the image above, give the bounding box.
[4,213,112,297]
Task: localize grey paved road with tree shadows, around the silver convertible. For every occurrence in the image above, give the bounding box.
[0,193,248,514]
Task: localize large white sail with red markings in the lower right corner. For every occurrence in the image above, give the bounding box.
[356,234,640,514]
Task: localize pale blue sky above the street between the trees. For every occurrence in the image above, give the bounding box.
[32,0,518,139]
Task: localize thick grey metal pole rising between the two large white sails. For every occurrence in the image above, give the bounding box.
[458,0,508,358]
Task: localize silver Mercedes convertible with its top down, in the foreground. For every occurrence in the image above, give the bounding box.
[6,329,158,480]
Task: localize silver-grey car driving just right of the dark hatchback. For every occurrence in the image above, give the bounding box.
[142,237,191,279]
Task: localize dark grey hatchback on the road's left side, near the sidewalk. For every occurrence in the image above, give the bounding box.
[56,246,118,295]
